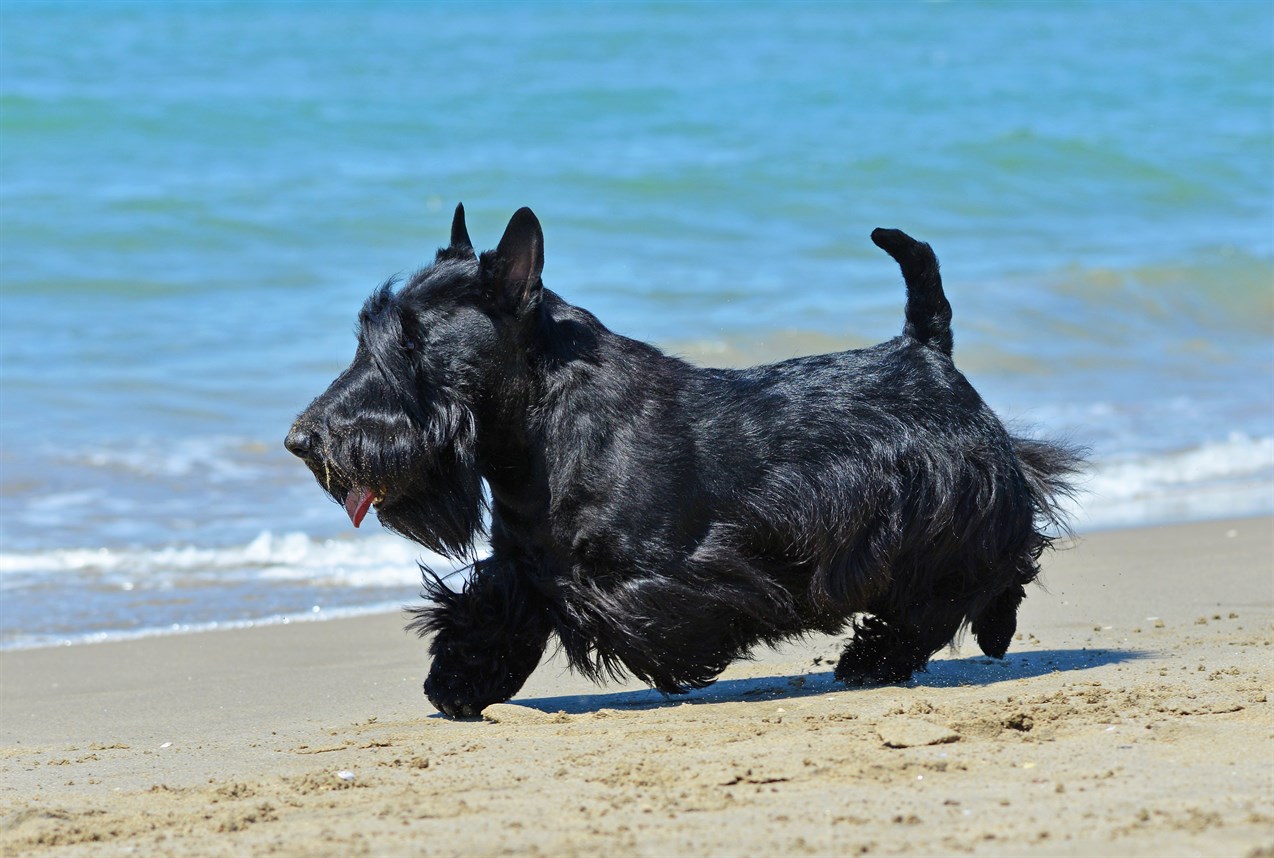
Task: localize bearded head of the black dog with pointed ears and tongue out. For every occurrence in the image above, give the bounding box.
[284,207,544,557]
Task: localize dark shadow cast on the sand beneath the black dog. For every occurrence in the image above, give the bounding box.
[511,649,1152,715]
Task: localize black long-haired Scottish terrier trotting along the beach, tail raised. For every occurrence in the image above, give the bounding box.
[287,207,1082,716]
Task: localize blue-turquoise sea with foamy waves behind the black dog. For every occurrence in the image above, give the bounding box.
[0,1,1274,645]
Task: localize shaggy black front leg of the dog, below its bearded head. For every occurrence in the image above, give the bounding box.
[410,557,553,718]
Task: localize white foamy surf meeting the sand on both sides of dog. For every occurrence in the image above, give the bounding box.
[0,433,1274,649]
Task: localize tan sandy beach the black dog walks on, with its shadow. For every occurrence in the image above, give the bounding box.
[0,518,1274,857]
